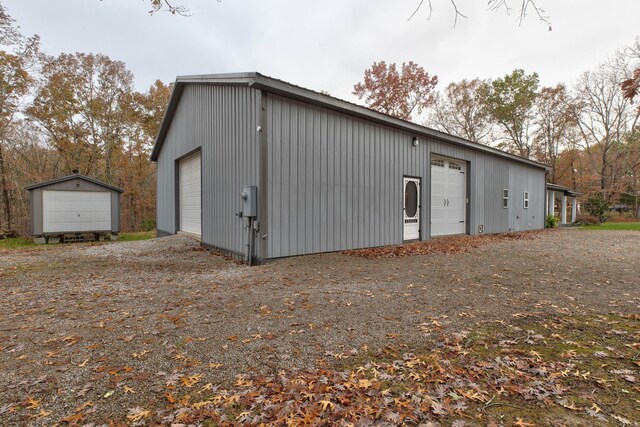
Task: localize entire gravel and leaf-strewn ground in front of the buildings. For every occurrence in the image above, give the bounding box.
[0,230,640,427]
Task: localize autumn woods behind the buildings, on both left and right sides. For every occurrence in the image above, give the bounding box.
[0,1,640,235]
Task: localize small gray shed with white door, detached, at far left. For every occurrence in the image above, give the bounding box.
[26,174,123,241]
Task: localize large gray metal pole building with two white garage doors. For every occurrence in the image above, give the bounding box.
[151,73,548,260]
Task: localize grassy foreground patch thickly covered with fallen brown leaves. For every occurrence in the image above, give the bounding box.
[128,315,640,427]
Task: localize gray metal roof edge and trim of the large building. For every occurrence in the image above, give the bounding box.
[151,72,551,170]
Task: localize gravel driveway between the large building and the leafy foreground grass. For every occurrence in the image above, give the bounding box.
[0,229,640,425]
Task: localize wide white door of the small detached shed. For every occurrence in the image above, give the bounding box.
[42,190,111,233]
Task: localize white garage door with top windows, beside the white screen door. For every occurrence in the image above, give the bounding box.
[431,157,467,236]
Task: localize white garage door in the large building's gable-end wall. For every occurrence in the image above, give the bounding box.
[178,153,202,236]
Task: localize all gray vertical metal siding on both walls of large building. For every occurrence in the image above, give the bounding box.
[154,85,545,258]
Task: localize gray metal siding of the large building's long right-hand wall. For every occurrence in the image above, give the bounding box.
[264,94,544,258]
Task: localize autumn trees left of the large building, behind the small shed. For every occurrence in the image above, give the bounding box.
[0,5,171,235]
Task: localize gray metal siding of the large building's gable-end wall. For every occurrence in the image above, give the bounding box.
[157,85,260,257]
